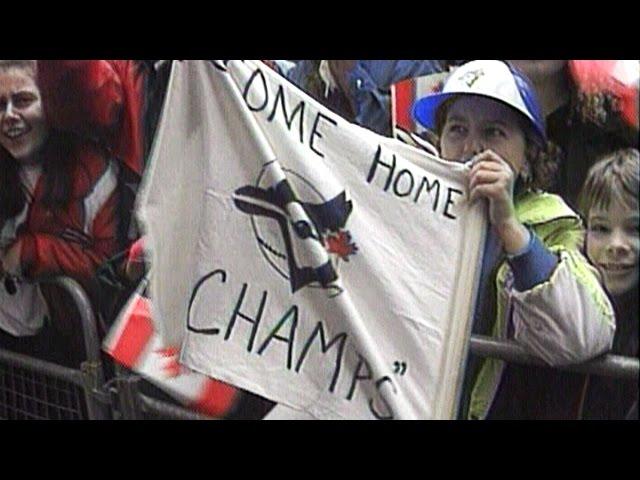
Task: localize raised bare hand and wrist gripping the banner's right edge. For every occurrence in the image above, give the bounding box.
[469,150,530,254]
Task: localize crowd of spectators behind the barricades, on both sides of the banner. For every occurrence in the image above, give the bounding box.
[0,60,640,419]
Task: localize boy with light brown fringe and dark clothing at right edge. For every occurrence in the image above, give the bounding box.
[580,149,640,420]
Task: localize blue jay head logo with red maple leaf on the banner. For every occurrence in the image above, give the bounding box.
[233,162,358,296]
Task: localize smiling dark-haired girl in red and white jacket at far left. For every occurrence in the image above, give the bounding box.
[0,60,130,356]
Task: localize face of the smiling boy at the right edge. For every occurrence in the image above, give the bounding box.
[587,200,640,296]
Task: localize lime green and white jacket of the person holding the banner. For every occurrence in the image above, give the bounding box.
[467,192,615,419]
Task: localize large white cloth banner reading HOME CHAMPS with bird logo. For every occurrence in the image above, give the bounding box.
[139,61,486,419]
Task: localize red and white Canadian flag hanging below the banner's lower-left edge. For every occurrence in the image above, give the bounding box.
[103,282,237,417]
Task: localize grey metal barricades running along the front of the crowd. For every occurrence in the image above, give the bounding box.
[0,277,640,420]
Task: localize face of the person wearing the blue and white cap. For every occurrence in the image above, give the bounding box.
[440,95,527,173]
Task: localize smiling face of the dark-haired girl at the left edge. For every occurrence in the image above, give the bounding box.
[0,68,47,163]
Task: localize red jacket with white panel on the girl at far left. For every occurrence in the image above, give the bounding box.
[10,143,119,284]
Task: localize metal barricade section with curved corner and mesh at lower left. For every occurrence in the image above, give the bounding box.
[0,277,111,420]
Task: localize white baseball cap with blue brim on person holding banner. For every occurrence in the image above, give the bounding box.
[413,60,547,145]
